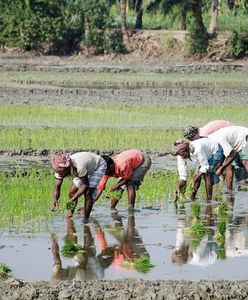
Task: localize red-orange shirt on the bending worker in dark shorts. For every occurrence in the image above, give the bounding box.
[97,149,143,191]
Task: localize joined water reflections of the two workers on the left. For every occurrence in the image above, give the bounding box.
[51,213,149,281]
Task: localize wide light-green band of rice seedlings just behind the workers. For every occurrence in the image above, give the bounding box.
[0,105,248,151]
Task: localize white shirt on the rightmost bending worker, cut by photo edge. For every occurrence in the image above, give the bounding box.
[208,126,248,157]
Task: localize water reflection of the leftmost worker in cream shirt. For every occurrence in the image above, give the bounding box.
[51,218,103,281]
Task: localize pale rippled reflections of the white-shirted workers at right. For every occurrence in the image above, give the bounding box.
[171,193,248,267]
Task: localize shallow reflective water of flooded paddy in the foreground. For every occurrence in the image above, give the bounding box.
[0,192,248,281]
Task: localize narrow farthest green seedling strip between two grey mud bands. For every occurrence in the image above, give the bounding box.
[0,70,248,87]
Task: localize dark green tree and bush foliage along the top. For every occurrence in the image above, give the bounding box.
[0,0,248,54]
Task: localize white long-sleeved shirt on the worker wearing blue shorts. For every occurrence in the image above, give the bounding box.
[177,138,218,180]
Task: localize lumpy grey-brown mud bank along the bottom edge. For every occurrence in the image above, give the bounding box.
[0,279,248,300]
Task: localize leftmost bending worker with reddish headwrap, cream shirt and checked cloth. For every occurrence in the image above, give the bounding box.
[51,152,107,223]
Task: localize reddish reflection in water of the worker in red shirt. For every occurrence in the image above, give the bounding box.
[96,215,148,269]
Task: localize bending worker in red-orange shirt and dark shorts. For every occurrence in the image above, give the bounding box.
[98,149,151,210]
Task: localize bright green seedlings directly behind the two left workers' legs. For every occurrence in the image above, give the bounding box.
[0,169,180,231]
